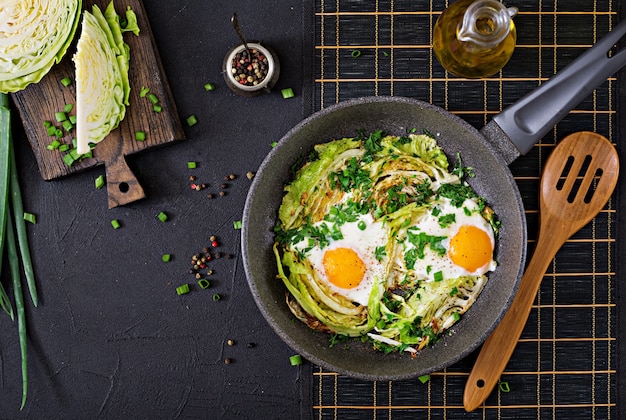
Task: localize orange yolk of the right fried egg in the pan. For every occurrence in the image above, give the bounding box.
[448,225,493,273]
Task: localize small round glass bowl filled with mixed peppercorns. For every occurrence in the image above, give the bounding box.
[222,41,280,97]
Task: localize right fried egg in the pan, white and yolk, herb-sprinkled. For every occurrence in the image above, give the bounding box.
[401,199,497,280]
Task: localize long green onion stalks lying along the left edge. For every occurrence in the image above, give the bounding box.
[0,94,38,410]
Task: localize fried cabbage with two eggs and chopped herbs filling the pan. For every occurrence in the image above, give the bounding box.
[274,130,498,355]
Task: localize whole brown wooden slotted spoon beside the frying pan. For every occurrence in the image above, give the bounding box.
[463,131,619,411]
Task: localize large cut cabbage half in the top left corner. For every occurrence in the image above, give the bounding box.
[0,0,82,93]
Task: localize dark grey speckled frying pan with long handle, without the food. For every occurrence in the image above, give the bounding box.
[241,21,626,380]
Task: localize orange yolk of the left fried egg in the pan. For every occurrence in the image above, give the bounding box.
[322,248,365,289]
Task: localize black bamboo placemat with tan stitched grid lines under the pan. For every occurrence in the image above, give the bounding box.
[313,0,621,419]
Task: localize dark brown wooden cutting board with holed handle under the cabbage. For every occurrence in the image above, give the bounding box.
[13,0,185,208]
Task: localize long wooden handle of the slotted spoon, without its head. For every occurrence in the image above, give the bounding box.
[463,220,567,412]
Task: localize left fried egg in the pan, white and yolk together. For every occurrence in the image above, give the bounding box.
[294,214,388,306]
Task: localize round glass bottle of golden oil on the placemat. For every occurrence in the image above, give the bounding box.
[433,0,517,78]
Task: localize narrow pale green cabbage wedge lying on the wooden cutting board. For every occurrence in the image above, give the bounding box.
[73,2,139,154]
